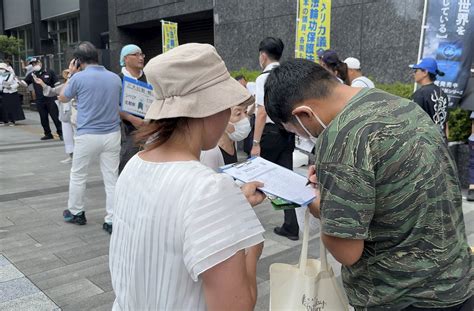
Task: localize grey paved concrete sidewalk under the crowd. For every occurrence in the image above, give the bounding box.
[0,111,474,310]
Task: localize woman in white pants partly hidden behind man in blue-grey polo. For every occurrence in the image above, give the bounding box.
[33,69,76,164]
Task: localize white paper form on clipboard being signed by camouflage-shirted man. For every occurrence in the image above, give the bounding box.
[222,157,316,206]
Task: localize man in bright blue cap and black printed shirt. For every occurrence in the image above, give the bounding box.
[410,57,448,136]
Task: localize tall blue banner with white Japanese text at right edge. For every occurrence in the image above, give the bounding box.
[421,0,474,107]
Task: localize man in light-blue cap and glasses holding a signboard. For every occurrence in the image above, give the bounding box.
[119,44,147,174]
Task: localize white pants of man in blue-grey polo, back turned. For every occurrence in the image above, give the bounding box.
[68,131,120,224]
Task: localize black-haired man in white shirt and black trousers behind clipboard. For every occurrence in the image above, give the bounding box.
[250,37,299,241]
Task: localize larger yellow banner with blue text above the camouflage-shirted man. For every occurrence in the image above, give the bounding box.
[295,0,331,61]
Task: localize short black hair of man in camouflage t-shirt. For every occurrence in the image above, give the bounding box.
[264,59,339,125]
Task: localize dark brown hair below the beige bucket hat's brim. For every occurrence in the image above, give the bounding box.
[135,117,188,150]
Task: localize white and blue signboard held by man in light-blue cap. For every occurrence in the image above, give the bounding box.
[120,77,155,118]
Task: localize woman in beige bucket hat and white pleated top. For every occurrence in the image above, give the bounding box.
[110,44,264,310]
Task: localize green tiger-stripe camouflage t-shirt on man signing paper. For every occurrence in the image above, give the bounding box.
[316,89,474,310]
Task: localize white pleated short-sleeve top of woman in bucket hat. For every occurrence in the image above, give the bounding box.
[109,154,264,311]
